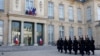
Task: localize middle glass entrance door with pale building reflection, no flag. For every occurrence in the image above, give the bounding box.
[24,22,34,46]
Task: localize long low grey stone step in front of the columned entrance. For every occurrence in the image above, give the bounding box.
[0,46,55,52]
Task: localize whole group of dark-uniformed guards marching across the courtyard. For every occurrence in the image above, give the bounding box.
[57,35,95,56]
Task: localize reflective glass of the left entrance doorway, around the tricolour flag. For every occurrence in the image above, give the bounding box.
[11,21,21,45]
